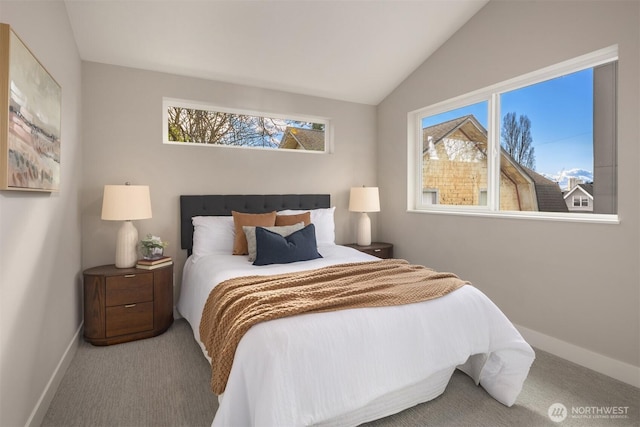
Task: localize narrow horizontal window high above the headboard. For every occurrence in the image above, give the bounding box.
[163,98,330,153]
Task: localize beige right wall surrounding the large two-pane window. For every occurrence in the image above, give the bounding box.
[378,1,640,384]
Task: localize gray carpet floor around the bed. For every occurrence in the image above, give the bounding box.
[42,320,640,427]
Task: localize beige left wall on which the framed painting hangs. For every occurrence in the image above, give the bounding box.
[0,1,82,426]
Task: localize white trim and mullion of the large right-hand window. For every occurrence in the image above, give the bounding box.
[407,45,620,224]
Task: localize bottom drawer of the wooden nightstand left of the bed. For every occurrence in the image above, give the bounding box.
[106,302,153,338]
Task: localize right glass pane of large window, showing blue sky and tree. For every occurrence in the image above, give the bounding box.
[500,68,615,213]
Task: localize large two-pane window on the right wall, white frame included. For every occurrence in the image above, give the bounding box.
[409,47,617,221]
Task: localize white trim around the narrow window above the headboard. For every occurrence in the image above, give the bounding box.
[162,97,333,154]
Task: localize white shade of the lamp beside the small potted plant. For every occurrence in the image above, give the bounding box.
[102,185,151,221]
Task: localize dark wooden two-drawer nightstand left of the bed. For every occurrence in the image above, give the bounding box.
[83,265,173,345]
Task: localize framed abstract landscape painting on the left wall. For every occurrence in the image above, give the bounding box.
[0,24,62,192]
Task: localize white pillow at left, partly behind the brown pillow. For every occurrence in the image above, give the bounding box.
[191,216,236,259]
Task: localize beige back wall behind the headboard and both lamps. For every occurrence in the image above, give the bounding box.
[81,63,377,297]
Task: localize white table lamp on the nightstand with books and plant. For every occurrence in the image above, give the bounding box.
[101,183,151,268]
